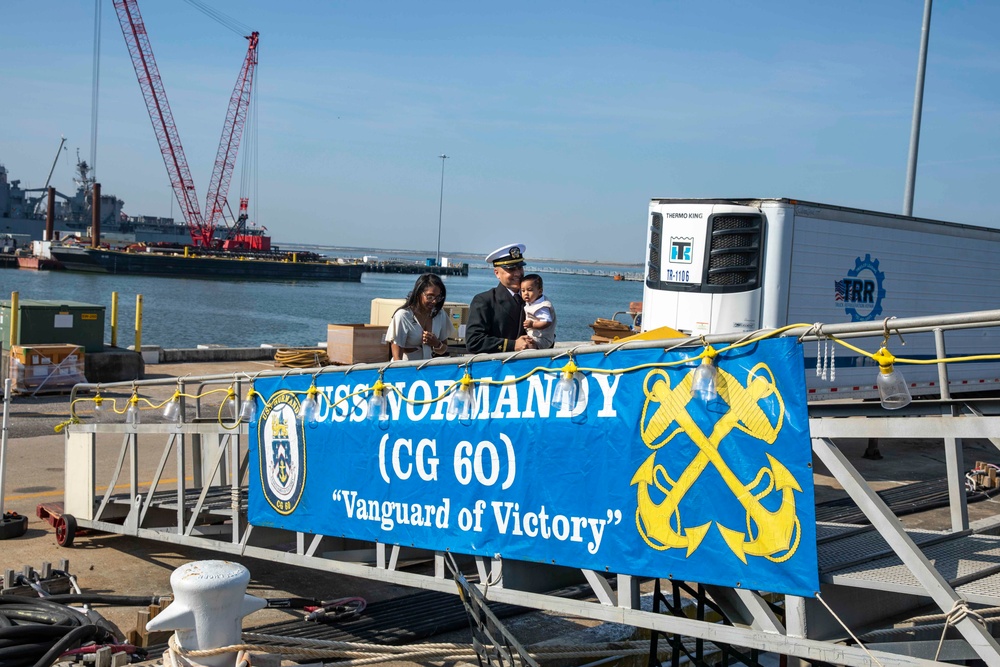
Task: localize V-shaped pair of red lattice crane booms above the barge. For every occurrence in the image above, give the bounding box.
[114,0,259,248]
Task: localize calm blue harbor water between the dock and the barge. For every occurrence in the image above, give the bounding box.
[0,264,642,348]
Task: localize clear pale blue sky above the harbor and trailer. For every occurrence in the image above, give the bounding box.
[0,0,1000,262]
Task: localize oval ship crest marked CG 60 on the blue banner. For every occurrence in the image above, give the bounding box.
[257,391,306,515]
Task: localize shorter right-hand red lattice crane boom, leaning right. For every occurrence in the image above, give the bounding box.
[205,31,260,236]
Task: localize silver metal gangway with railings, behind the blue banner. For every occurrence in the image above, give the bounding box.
[57,311,1000,667]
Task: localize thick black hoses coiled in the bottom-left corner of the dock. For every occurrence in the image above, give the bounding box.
[0,595,117,667]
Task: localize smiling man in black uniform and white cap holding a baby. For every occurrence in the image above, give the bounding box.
[465,243,535,353]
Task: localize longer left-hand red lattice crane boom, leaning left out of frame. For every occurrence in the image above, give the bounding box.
[114,0,213,247]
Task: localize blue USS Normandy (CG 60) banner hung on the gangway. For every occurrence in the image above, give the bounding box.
[249,339,819,596]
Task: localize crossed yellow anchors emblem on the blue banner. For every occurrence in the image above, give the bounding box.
[630,364,802,563]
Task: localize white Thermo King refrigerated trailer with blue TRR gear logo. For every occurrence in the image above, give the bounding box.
[642,198,1000,399]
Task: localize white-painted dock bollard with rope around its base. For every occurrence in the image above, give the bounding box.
[146,560,267,667]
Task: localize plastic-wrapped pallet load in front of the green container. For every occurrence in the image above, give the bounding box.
[10,344,87,394]
